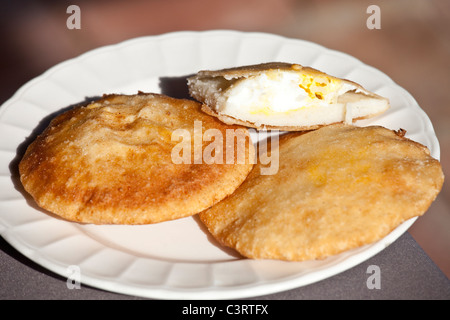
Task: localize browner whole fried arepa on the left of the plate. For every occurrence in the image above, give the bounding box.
[19,92,254,224]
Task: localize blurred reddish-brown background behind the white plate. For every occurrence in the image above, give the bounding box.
[0,0,450,278]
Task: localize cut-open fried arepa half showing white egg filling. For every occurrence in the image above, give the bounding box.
[188,62,389,131]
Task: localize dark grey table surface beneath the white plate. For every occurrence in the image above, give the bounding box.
[0,232,450,300]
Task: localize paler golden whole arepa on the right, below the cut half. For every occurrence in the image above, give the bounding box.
[199,125,444,261]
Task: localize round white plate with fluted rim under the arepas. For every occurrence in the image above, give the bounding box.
[0,30,440,299]
